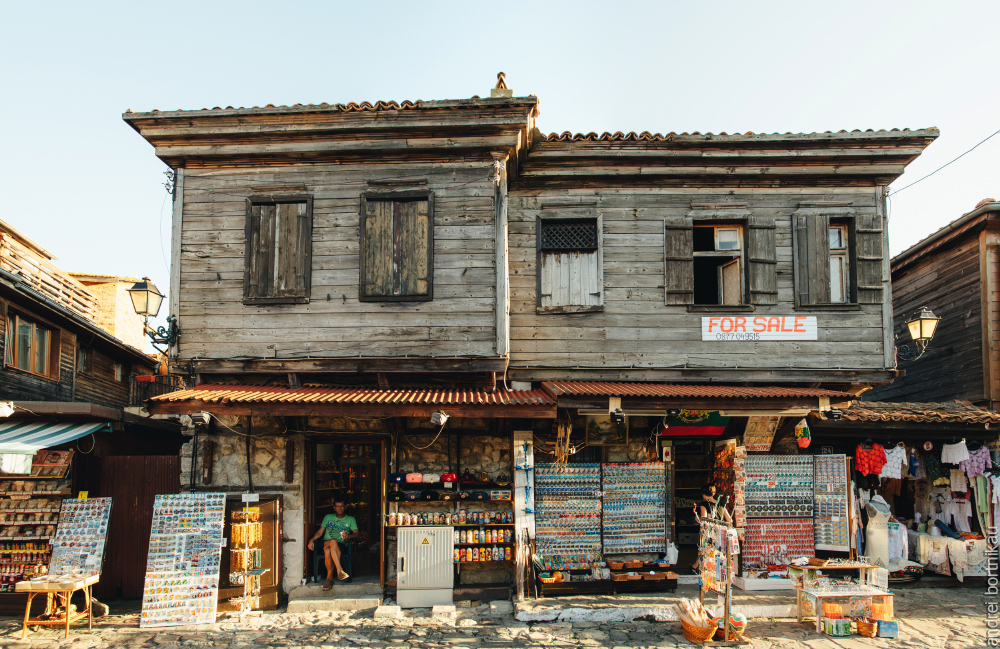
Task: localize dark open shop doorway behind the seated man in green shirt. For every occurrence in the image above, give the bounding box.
[308,442,385,581]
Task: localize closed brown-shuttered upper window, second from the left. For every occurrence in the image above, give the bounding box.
[359,194,434,302]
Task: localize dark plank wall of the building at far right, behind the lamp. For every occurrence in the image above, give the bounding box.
[864,236,995,402]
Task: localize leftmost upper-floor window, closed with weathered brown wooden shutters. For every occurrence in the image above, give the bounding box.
[243,198,312,304]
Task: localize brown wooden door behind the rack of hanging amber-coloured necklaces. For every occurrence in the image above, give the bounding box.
[219,496,282,611]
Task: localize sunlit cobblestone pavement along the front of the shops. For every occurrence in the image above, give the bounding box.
[0,587,992,649]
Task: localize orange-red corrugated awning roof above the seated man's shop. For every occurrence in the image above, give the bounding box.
[151,384,555,406]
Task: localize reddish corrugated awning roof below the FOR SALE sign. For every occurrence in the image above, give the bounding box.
[542,381,853,400]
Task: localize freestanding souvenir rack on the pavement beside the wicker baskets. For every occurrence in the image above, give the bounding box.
[698,519,749,646]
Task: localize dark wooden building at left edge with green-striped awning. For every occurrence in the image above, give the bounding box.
[0,220,182,613]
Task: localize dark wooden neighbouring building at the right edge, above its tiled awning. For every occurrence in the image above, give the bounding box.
[864,200,1000,410]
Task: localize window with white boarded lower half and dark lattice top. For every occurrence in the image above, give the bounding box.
[537,217,604,313]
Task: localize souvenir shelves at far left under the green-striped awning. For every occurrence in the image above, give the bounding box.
[0,450,74,593]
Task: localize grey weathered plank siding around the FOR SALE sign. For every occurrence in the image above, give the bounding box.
[509,188,885,378]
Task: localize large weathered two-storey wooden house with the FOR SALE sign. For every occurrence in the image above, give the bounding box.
[124,92,937,591]
